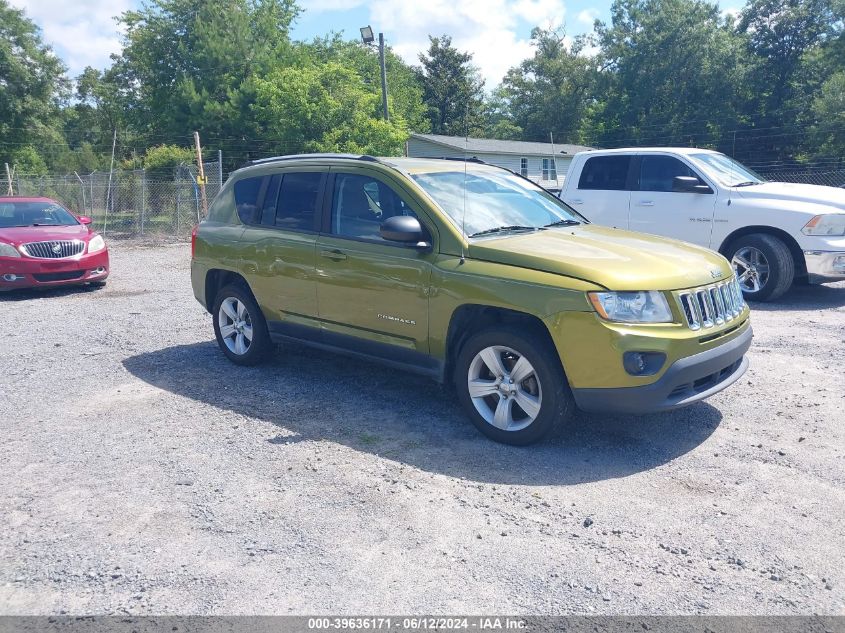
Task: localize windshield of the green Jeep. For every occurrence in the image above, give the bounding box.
[411,169,584,237]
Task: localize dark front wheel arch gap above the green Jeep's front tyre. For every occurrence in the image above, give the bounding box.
[443,303,560,384]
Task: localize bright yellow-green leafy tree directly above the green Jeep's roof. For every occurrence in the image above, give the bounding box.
[254,62,408,156]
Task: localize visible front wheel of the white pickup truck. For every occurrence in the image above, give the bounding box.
[727,233,795,301]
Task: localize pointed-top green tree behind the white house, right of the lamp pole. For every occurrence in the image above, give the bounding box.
[499,28,596,143]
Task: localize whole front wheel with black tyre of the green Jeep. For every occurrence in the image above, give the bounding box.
[454,327,575,446]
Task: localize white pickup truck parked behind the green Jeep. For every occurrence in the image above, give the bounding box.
[560,148,845,301]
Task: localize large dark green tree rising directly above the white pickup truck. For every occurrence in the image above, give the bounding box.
[584,0,749,151]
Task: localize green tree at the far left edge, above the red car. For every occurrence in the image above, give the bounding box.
[0,0,67,169]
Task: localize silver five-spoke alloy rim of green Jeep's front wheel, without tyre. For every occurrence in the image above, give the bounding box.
[467,345,543,431]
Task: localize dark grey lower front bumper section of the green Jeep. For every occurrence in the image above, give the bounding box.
[572,326,753,413]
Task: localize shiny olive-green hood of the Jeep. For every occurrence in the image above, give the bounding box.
[469,224,733,290]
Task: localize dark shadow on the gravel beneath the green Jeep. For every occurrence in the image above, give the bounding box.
[123,342,722,485]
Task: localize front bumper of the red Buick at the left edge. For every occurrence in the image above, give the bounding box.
[0,249,109,291]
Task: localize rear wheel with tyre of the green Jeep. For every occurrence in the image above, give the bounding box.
[211,284,272,365]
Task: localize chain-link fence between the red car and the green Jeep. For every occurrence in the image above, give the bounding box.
[0,161,223,239]
